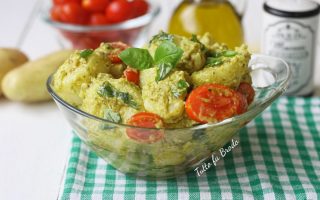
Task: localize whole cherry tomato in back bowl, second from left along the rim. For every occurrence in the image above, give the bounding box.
[60,2,89,24]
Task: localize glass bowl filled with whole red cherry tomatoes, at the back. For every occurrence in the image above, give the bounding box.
[42,0,160,49]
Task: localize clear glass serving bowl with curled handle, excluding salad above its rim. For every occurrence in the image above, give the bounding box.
[47,55,291,178]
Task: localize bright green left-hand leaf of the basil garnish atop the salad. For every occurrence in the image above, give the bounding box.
[119,48,153,70]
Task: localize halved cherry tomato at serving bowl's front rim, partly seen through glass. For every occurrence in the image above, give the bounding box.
[127,112,164,143]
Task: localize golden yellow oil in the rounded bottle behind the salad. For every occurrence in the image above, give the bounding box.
[168,0,243,48]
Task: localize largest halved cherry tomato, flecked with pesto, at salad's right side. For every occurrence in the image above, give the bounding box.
[185,84,245,123]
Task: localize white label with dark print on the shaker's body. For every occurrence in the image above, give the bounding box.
[264,21,315,94]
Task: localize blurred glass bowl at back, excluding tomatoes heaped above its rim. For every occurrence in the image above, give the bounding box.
[41,1,160,49]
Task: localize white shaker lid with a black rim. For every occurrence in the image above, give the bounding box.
[264,0,320,18]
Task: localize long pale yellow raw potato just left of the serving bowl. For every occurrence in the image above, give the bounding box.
[2,50,73,102]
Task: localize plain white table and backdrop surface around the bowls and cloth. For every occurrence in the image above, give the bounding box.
[0,0,320,200]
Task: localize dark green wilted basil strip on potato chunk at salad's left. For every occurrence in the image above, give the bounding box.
[97,83,139,109]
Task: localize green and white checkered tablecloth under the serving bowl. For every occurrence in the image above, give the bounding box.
[59,97,320,200]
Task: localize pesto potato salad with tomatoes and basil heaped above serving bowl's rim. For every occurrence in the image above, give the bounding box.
[52,32,254,143]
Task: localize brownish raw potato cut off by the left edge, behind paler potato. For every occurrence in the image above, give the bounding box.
[0,48,28,96]
